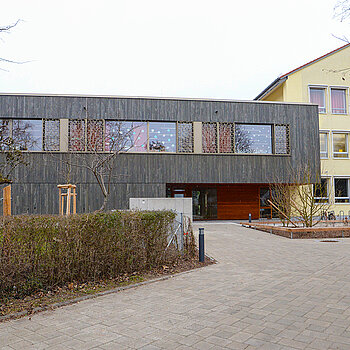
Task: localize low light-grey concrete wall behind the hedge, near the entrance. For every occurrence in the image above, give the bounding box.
[129,198,192,221]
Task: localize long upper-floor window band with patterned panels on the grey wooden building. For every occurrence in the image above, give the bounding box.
[0,119,290,154]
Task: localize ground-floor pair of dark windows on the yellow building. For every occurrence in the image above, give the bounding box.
[314,177,350,203]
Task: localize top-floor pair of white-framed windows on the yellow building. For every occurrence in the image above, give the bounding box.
[309,87,348,114]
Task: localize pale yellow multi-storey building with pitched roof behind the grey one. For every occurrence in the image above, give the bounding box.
[255,44,350,216]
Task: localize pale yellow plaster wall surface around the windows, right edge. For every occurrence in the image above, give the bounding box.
[264,47,350,216]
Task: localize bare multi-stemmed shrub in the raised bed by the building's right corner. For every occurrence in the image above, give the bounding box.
[270,166,331,227]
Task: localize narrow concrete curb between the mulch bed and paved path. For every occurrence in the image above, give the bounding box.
[0,254,218,323]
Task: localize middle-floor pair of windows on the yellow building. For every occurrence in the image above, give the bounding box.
[320,131,349,159]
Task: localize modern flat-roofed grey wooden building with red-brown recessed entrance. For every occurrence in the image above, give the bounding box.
[0,94,320,219]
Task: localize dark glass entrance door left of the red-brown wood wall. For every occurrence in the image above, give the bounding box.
[192,188,218,220]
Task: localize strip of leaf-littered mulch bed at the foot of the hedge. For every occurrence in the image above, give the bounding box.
[0,253,216,322]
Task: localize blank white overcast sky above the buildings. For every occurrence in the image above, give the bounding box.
[0,0,350,99]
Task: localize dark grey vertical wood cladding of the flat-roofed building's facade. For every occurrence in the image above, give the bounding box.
[0,94,320,214]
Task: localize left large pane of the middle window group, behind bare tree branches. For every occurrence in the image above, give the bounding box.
[105,120,147,152]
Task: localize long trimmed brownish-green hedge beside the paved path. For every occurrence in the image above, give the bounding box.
[0,211,178,299]
